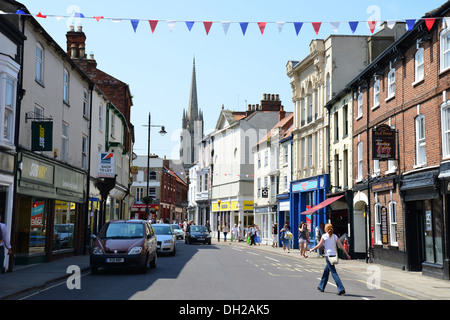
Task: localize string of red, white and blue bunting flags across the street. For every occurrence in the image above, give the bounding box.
[0,10,442,36]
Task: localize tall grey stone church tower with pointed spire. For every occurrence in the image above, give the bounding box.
[180,58,203,168]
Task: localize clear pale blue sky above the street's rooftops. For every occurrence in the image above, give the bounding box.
[20,0,444,159]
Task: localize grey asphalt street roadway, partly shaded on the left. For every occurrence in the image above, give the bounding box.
[17,241,411,302]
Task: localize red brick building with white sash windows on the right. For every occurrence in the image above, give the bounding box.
[349,2,450,279]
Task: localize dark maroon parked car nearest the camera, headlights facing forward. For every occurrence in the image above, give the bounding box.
[90,220,157,274]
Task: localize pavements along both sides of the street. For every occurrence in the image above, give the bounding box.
[0,238,450,300]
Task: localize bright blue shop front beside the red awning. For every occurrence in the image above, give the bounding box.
[286,174,330,249]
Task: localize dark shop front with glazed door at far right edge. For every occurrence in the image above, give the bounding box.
[400,170,442,278]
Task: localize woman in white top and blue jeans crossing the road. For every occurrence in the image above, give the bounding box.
[310,223,350,295]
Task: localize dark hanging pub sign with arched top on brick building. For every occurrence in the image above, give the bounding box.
[372,124,395,160]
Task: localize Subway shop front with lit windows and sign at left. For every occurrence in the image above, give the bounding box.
[12,152,86,265]
